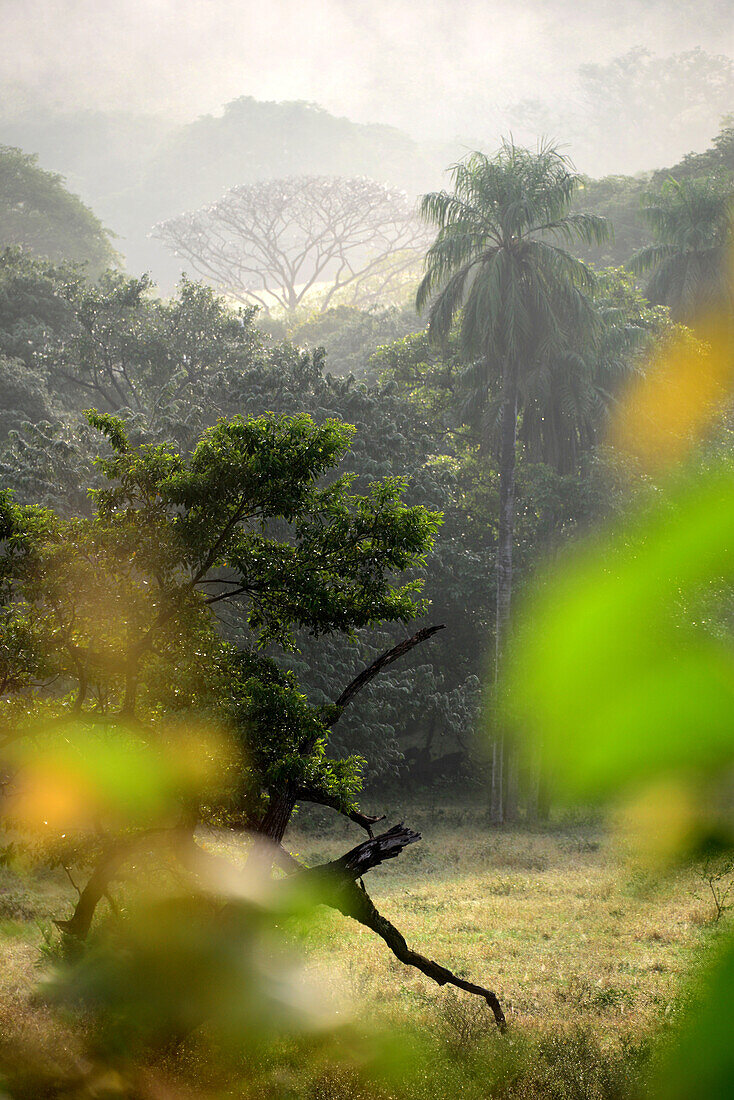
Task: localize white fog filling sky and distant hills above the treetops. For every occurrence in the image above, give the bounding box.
[0,0,734,285]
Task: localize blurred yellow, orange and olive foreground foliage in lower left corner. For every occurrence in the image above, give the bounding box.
[0,715,343,1098]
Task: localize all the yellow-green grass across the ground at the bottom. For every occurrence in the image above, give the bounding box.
[0,795,727,1100]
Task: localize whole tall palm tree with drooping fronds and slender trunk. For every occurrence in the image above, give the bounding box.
[417,141,606,821]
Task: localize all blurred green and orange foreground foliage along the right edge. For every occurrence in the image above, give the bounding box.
[506,264,734,1100]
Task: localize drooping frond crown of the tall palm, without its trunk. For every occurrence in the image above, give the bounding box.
[417,143,605,364]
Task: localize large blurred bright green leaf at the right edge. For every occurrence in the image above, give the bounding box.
[507,469,734,798]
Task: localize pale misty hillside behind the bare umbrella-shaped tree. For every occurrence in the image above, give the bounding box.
[0,97,459,285]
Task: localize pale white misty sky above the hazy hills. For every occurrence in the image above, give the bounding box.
[5,0,734,139]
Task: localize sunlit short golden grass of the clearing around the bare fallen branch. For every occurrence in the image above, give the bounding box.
[274,800,712,1034]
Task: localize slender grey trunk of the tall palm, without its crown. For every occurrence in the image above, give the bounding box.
[490,369,517,825]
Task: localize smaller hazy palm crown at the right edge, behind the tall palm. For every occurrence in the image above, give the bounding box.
[631,177,734,321]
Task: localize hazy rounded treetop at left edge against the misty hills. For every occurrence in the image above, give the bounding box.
[0,145,116,275]
